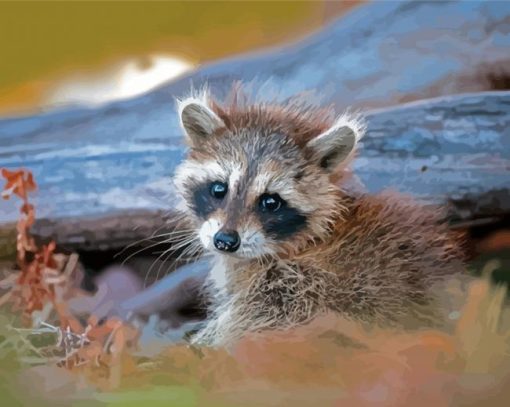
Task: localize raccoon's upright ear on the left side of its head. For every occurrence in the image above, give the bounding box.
[178,98,225,146]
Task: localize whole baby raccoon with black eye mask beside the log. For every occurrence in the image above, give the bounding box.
[175,90,462,345]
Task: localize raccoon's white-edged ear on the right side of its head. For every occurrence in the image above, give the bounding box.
[306,115,366,172]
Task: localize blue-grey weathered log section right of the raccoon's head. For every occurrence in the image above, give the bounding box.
[355,92,510,221]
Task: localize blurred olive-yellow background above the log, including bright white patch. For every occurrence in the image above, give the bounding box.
[0,0,362,117]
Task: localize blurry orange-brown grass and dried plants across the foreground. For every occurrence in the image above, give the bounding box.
[0,167,510,407]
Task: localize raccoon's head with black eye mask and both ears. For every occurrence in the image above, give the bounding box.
[174,91,364,259]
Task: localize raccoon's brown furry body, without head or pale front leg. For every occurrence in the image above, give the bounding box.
[229,193,463,326]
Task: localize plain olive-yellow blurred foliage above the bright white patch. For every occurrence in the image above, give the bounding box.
[0,0,323,90]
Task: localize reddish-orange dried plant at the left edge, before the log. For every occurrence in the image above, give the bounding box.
[0,169,138,388]
